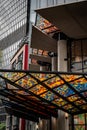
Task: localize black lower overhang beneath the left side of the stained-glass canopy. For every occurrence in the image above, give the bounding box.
[2,99,39,122]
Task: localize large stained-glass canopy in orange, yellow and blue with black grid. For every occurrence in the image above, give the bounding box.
[0,70,87,118]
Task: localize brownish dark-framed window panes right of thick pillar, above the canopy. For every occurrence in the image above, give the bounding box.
[71,40,87,72]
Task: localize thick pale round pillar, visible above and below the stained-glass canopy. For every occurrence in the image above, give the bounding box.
[57,33,69,130]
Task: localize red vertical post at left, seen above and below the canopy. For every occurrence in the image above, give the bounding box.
[20,44,29,130]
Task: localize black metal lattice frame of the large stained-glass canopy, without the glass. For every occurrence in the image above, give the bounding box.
[0,70,87,121]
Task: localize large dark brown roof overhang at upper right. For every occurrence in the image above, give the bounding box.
[36,0,87,39]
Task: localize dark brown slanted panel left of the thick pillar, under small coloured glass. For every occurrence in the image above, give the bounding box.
[31,26,57,52]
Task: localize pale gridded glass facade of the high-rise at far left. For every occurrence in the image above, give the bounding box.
[0,0,27,69]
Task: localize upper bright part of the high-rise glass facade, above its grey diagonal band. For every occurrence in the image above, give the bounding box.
[0,0,27,40]
